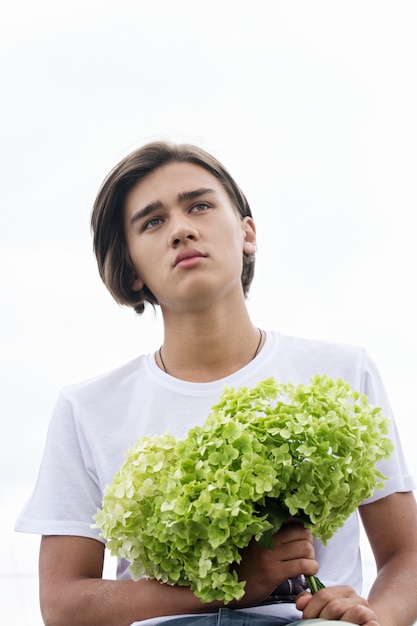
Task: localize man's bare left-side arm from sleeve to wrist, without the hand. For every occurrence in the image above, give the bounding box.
[39,536,218,626]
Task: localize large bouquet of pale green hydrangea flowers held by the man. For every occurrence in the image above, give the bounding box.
[94,375,392,603]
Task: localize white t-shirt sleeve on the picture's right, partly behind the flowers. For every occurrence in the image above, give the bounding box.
[360,351,416,504]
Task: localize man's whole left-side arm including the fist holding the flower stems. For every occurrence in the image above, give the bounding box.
[40,524,318,626]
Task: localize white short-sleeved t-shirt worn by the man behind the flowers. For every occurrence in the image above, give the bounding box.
[16,332,415,621]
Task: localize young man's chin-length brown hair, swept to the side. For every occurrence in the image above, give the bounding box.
[91,141,254,314]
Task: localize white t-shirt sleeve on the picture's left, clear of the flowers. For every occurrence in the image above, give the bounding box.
[16,393,102,539]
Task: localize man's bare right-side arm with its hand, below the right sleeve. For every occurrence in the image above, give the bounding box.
[297,492,417,626]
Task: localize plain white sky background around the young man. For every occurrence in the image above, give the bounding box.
[0,0,417,626]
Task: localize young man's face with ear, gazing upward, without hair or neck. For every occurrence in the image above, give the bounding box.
[124,162,255,310]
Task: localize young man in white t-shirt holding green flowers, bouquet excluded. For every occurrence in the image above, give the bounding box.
[17,143,417,626]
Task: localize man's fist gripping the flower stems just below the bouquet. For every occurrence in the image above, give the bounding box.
[233,522,318,607]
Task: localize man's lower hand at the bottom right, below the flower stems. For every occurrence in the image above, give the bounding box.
[296,586,380,626]
